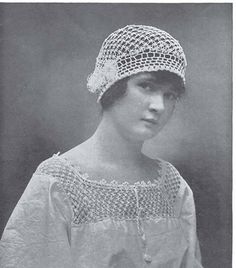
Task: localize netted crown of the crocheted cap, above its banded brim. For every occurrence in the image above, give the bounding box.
[97,25,184,64]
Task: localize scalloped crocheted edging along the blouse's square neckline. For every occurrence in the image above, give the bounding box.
[52,152,165,189]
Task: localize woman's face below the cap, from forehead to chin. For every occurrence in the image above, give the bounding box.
[107,72,178,141]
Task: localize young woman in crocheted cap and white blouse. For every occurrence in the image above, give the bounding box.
[1,25,202,268]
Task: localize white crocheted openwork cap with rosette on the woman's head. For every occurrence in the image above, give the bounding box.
[87,25,187,101]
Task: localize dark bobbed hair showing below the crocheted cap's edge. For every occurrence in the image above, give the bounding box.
[100,71,185,111]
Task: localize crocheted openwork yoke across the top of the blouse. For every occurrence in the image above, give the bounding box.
[36,155,180,224]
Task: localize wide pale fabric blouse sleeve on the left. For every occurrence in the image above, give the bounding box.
[0,174,73,268]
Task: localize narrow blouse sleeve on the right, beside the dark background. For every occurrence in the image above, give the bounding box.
[180,180,203,268]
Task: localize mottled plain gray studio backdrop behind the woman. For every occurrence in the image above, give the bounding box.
[0,3,232,268]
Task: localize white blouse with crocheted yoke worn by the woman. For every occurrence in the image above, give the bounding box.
[0,154,202,268]
